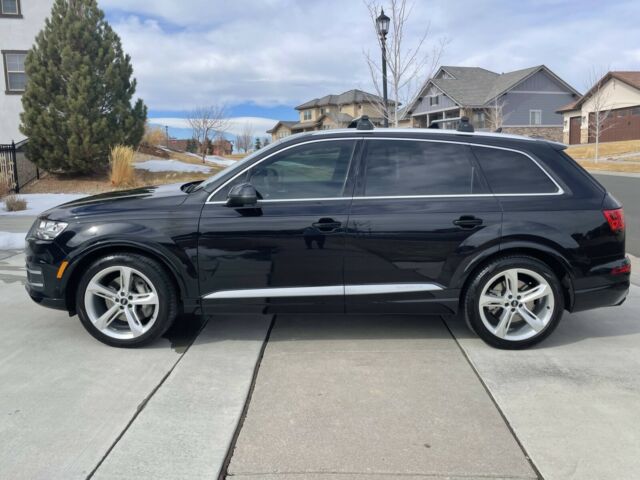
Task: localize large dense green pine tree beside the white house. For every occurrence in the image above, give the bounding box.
[20,0,147,173]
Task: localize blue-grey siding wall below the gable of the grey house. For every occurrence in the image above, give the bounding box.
[502,91,574,126]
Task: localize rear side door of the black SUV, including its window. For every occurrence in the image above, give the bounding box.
[345,139,502,314]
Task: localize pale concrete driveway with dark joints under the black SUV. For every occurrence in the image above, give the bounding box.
[0,246,640,480]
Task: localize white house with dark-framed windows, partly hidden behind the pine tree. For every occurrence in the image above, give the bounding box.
[0,0,53,143]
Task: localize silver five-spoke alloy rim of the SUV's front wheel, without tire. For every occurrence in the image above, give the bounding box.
[84,265,160,340]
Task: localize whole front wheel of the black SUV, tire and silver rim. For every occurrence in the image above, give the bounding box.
[76,254,177,347]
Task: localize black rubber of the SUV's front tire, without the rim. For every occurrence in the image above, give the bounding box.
[76,253,178,348]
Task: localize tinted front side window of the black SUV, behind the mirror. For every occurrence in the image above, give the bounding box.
[215,140,355,200]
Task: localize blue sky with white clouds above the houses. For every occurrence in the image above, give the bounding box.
[99,0,640,137]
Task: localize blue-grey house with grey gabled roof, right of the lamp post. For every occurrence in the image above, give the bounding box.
[401,65,580,141]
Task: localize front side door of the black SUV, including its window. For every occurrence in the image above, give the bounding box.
[198,139,359,312]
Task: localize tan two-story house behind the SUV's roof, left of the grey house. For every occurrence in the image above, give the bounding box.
[267,90,383,141]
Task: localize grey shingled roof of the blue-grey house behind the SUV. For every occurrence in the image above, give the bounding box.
[406,65,579,116]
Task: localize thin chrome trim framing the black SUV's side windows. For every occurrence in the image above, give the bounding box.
[205,137,565,205]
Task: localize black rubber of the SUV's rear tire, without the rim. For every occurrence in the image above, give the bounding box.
[463,255,564,350]
